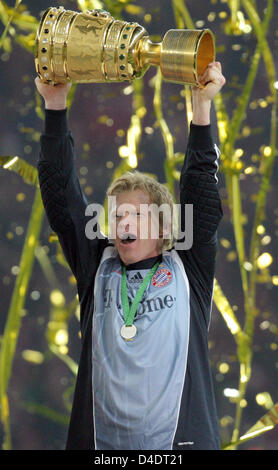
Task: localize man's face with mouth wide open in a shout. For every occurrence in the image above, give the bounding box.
[111,190,162,265]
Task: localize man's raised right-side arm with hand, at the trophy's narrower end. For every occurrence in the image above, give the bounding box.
[179,62,225,323]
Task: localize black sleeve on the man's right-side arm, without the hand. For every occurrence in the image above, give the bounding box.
[179,123,223,325]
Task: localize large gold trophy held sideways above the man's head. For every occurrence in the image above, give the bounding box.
[35,7,215,86]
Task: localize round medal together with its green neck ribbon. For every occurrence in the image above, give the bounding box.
[121,262,159,341]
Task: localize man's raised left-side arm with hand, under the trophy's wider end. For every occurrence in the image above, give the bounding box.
[35,78,106,295]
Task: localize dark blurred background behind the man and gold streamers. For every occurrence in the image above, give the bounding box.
[0,0,278,450]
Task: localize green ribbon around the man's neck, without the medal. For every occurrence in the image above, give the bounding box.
[121,262,160,326]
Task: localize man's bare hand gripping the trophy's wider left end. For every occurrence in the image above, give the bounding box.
[35,77,71,110]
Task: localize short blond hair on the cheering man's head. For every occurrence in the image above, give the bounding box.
[106,171,174,250]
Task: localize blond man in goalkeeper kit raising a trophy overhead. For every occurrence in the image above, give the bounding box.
[36,62,225,450]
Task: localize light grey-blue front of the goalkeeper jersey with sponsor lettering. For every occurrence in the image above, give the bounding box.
[92,247,190,450]
